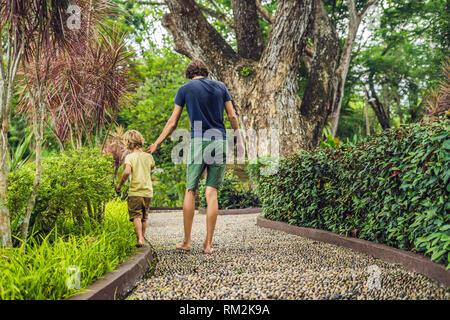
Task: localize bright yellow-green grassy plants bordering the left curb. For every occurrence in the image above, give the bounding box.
[0,201,136,300]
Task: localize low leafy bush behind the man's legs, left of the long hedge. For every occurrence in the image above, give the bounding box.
[198,170,260,209]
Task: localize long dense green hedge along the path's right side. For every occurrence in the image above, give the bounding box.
[250,119,450,267]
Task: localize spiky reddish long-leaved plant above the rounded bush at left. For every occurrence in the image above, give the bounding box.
[16,0,131,149]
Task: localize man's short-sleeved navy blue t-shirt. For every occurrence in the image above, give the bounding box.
[175,78,233,140]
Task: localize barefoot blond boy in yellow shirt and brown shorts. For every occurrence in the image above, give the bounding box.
[116,130,155,247]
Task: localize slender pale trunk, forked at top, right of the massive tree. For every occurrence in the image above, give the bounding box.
[330,0,378,136]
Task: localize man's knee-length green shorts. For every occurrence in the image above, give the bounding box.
[186,138,227,190]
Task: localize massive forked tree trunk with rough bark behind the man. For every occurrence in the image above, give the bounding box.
[163,0,328,156]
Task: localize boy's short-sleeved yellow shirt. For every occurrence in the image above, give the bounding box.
[125,152,155,198]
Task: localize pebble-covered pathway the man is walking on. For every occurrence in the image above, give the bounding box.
[127,211,450,300]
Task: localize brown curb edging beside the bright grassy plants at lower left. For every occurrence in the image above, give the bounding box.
[68,244,153,300]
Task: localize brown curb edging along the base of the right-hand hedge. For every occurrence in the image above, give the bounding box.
[256,217,450,287]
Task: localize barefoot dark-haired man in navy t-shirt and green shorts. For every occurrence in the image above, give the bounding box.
[146,60,244,254]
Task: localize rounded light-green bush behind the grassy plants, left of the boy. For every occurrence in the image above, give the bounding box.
[8,149,114,238]
